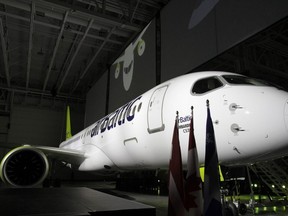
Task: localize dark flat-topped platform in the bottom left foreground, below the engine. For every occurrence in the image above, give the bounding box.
[0,183,155,216]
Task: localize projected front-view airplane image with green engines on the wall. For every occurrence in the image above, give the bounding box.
[112,24,150,91]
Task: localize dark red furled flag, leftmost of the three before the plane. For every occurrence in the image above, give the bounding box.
[168,113,184,216]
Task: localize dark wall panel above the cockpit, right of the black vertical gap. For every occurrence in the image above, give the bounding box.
[161,0,288,81]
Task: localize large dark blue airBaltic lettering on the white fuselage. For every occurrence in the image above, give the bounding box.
[91,96,142,137]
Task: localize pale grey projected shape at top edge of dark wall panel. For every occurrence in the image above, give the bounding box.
[188,0,219,29]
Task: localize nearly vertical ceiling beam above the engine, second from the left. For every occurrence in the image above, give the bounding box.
[26,1,35,88]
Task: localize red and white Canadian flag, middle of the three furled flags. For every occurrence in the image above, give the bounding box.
[185,107,203,216]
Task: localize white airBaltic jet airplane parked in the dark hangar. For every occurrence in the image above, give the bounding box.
[0,71,288,187]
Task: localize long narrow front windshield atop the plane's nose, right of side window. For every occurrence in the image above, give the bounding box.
[222,75,269,86]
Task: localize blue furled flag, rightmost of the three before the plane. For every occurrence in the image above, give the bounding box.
[203,100,222,216]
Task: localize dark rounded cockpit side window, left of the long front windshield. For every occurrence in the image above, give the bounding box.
[192,77,223,94]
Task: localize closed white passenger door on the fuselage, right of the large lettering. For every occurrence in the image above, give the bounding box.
[148,85,168,134]
